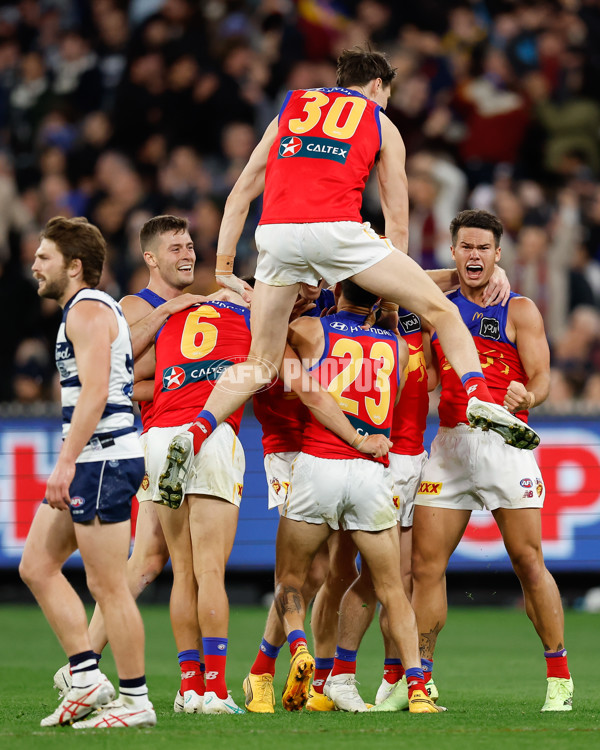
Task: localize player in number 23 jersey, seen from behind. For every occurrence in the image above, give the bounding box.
[275,281,446,713]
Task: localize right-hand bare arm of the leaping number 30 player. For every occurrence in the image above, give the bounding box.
[377,113,408,253]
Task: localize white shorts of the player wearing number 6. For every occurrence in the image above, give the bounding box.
[144,422,246,506]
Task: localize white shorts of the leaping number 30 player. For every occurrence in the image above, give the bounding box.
[254,221,394,286]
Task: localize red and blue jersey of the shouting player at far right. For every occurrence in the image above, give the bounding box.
[431,289,528,427]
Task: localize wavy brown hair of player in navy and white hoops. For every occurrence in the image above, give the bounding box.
[40,216,106,289]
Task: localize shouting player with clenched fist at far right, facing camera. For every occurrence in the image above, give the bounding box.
[413,211,573,711]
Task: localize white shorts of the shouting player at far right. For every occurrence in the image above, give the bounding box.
[415,424,546,510]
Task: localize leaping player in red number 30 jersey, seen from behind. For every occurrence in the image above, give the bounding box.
[157,49,539,506]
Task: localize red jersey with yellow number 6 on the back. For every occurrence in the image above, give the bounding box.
[148,300,250,433]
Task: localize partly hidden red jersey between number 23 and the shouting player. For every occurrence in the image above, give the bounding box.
[390,308,429,456]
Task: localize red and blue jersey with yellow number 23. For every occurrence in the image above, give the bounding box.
[302,311,400,466]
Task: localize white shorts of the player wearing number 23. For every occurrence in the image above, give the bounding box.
[281,452,396,531]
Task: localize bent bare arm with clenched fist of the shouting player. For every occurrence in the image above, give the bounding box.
[504,297,550,412]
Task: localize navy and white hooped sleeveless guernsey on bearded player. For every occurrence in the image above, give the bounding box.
[55,288,143,463]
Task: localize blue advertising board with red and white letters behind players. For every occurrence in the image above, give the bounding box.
[0,417,600,572]
